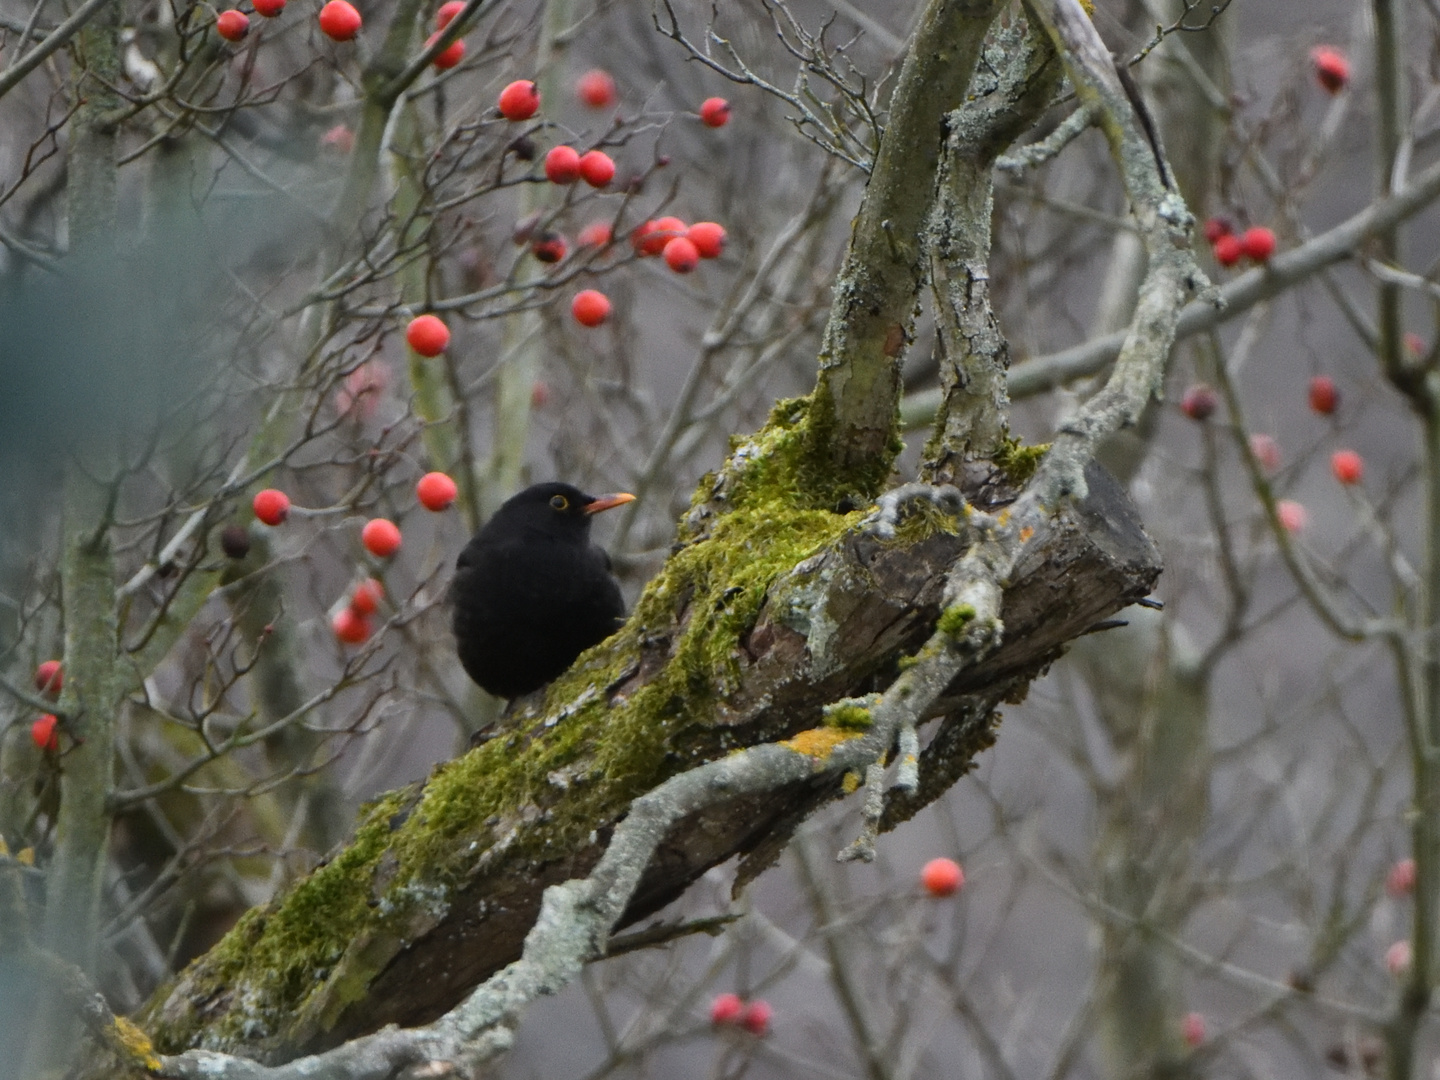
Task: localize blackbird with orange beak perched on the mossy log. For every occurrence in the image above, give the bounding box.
[449,484,635,697]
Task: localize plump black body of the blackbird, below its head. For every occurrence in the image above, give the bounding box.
[451,531,625,697]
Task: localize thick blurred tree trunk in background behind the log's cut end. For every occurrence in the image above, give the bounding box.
[1071,0,1230,1079]
